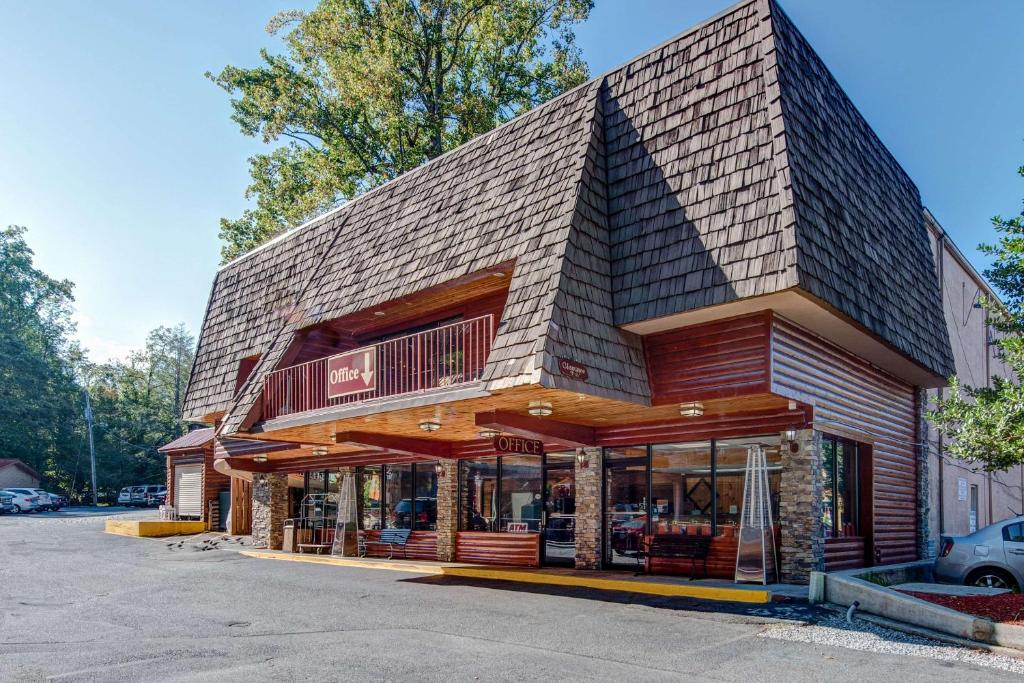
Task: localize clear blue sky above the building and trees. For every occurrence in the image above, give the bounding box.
[0,0,1024,360]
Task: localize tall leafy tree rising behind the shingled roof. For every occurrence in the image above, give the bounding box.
[207,0,593,261]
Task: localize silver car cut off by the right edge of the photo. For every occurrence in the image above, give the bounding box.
[935,515,1024,591]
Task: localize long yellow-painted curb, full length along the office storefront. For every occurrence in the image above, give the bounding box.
[239,550,771,604]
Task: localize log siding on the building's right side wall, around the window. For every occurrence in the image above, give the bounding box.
[772,316,918,564]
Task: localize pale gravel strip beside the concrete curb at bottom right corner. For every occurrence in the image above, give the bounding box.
[761,615,1024,674]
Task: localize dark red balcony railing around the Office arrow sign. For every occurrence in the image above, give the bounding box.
[263,315,494,420]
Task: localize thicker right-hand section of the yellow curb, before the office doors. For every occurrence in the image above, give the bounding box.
[443,567,771,604]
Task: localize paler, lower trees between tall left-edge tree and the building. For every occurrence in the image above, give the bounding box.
[88,325,196,495]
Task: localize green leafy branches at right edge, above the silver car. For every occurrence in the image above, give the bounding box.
[930,167,1024,472]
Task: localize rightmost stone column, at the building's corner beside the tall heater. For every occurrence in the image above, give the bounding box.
[778,429,824,584]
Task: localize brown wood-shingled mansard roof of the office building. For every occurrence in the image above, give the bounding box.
[184,0,951,433]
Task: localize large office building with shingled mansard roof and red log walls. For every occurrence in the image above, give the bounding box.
[184,0,953,581]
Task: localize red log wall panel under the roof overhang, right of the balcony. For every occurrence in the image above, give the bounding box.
[644,311,771,405]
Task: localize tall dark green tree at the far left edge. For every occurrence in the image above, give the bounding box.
[0,225,82,488]
